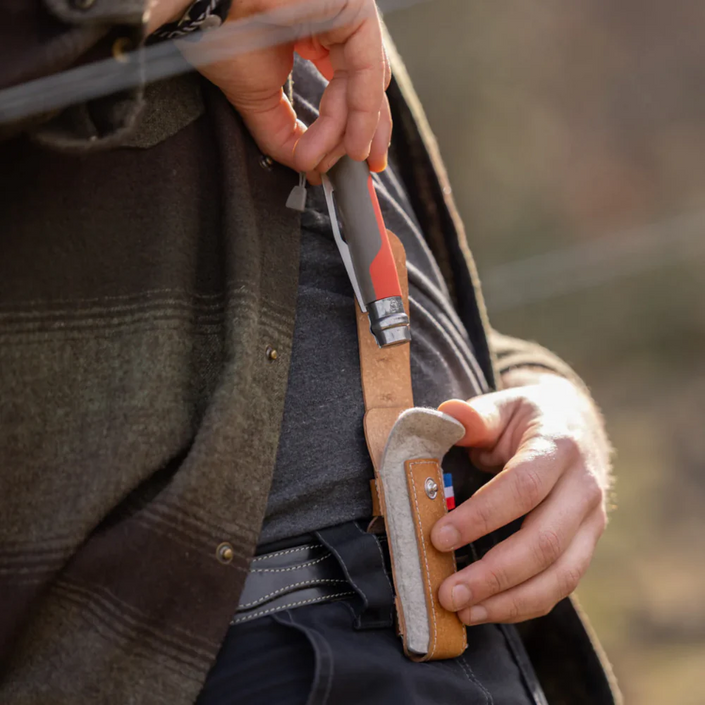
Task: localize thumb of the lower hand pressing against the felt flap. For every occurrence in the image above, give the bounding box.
[438,391,519,449]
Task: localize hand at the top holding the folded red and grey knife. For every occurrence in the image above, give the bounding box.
[182,0,392,175]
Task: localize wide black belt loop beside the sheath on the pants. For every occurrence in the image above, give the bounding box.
[314,521,394,629]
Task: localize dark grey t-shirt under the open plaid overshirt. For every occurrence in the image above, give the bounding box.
[260,60,487,543]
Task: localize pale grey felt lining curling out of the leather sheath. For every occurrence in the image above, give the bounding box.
[379,408,465,654]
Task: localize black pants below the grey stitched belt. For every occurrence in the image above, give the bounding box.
[198,524,545,705]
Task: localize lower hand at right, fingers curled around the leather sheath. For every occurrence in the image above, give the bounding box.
[431,375,610,624]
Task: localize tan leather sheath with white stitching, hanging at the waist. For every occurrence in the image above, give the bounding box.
[355,232,467,661]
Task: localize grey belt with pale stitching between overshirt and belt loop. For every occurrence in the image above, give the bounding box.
[231,541,355,624]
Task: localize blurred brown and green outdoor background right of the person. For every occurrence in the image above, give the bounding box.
[386,0,705,705]
